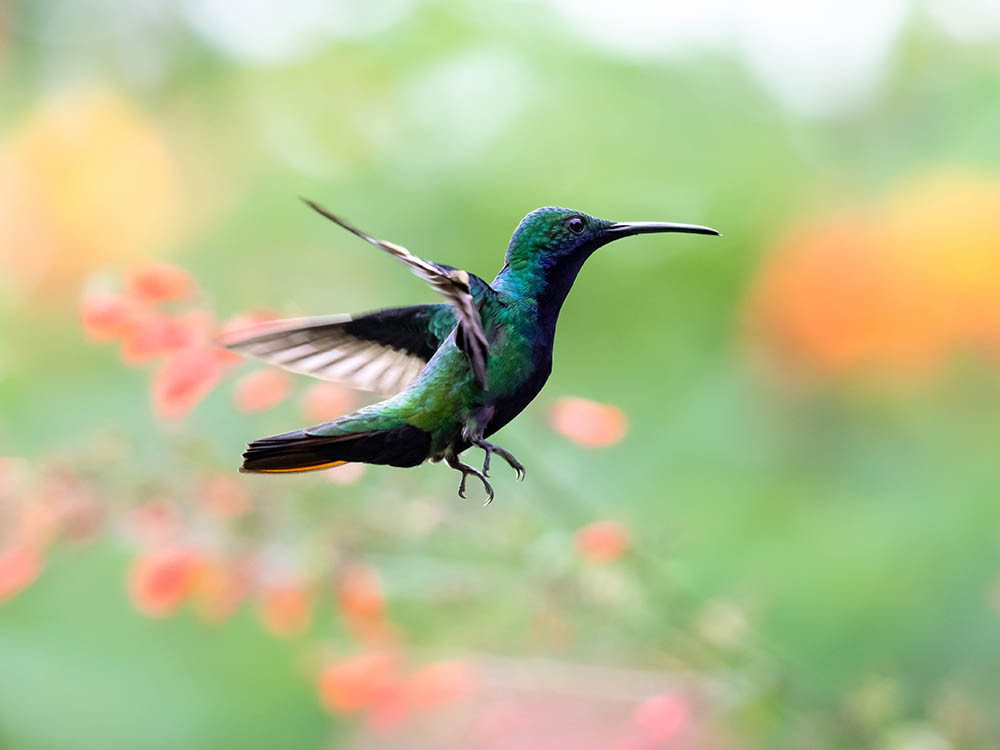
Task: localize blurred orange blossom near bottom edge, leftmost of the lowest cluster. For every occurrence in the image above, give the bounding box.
[317,651,401,714]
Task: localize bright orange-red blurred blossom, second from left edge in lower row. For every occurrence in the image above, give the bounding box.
[128,548,200,617]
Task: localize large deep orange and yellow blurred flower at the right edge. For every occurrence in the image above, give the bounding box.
[747,173,1000,378]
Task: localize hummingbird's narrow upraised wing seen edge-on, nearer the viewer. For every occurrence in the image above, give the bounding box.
[306,200,489,388]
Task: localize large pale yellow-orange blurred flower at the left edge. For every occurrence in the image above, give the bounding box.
[0,91,178,306]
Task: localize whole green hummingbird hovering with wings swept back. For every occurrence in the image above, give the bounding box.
[222,201,719,503]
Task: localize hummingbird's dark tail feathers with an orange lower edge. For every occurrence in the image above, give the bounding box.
[240,425,431,474]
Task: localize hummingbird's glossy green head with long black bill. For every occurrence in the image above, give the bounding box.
[507,206,719,276]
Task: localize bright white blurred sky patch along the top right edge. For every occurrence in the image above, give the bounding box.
[549,0,1000,115]
